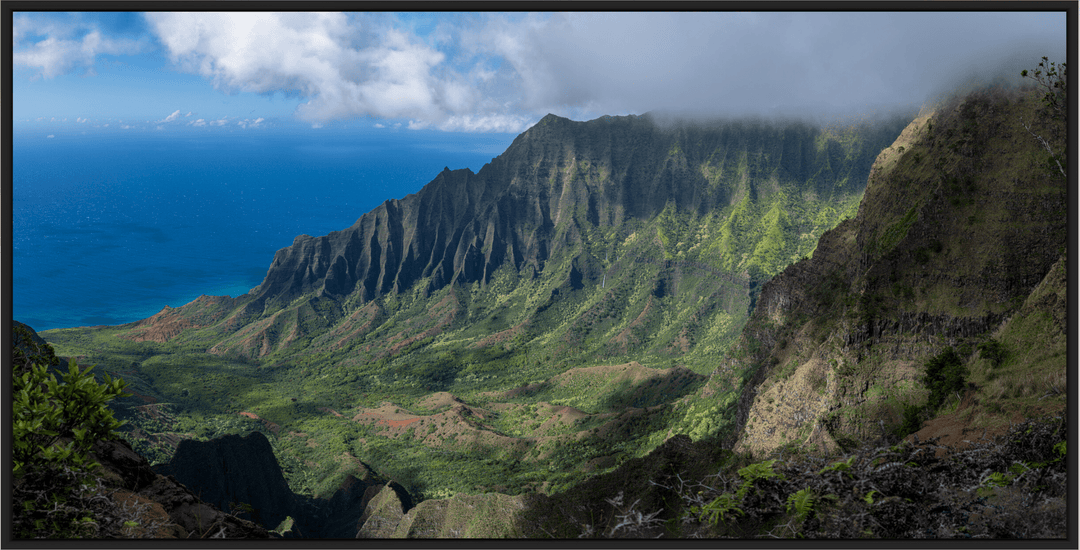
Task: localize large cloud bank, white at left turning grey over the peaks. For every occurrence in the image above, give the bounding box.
[143,12,1065,132]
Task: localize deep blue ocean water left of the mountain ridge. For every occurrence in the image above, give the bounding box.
[12,129,514,331]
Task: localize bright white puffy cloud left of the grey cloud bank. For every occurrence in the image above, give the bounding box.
[147,12,527,128]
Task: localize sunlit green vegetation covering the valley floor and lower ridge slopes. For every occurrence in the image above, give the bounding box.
[43,113,903,507]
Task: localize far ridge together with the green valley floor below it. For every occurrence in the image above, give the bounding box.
[44,110,907,496]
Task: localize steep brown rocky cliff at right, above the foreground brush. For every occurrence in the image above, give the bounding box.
[729,84,1067,453]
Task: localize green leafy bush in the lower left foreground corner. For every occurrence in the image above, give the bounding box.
[11,325,125,538]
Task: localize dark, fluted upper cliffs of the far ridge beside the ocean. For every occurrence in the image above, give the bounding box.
[253,115,894,308]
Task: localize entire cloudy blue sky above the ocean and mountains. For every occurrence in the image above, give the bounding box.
[12,12,1066,133]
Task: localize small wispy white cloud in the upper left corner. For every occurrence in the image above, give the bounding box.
[12,14,147,79]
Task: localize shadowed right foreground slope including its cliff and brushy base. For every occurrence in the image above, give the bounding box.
[507,82,1070,538]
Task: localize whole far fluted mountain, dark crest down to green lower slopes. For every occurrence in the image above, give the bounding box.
[124,110,906,369]
